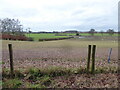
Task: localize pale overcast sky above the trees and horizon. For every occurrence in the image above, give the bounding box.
[0,0,119,32]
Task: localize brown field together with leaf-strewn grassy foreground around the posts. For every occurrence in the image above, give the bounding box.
[2,36,118,88]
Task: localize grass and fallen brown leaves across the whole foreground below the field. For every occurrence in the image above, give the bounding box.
[2,67,117,88]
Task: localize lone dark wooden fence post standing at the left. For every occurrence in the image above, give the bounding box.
[8,44,14,78]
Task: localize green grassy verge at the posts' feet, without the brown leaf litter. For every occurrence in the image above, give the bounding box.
[2,67,117,88]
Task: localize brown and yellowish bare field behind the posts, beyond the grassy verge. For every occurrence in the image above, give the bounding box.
[3,37,118,67]
